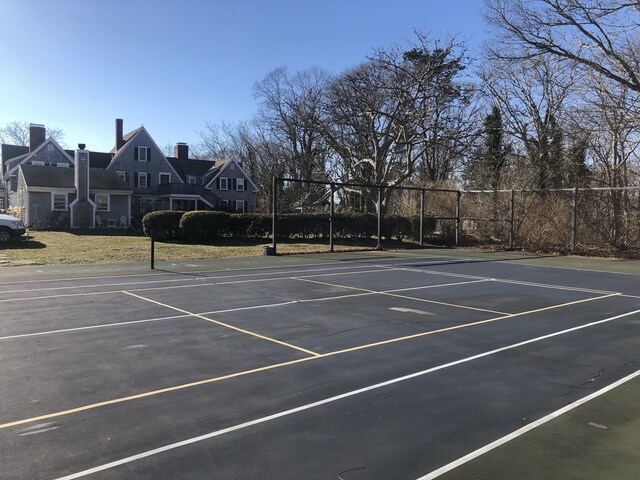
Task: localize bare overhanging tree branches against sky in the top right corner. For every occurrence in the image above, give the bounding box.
[485,0,640,92]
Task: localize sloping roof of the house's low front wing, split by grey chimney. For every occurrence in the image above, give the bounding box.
[20,164,131,192]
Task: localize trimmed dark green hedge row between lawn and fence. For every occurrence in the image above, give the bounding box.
[142,210,435,242]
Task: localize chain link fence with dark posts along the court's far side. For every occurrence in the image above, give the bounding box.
[271,178,640,255]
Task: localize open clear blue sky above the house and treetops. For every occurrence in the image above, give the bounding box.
[0,0,485,151]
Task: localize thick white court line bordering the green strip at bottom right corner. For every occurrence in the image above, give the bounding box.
[417,370,640,480]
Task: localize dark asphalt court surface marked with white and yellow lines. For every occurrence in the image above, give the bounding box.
[0,251,640,480]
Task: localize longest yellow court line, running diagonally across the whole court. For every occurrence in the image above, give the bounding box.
[0,293,621,430]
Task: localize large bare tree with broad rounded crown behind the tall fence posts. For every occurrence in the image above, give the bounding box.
[322,34,469,208]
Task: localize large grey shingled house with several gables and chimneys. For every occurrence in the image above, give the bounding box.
[0,119,258,227]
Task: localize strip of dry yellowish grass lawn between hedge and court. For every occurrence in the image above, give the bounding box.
[0,231,375,265]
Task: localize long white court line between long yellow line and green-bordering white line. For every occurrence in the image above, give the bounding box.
[57,310,640,480]
